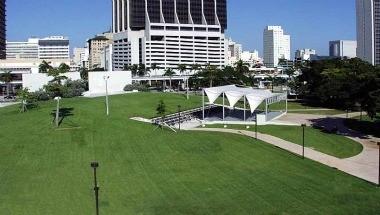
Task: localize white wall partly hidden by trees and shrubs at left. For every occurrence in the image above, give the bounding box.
[22,72,80,92]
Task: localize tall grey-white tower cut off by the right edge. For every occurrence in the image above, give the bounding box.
[356,0,380,65]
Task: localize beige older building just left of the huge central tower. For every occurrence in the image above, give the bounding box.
[87,33,113,69]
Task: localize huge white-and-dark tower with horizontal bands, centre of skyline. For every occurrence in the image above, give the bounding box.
[112,0,227,70]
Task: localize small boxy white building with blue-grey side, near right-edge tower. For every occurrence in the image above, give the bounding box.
[329,40,357,58]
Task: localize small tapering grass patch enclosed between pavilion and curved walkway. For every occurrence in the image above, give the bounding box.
[203,125,363,158]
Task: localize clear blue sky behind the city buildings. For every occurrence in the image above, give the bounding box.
[7,0,356,56]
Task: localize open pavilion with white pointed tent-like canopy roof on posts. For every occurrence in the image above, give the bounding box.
[202,85,288,121]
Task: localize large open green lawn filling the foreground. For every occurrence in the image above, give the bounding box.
[0,93,380,215]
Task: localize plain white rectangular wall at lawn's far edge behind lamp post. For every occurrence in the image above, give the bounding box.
[88,71,132,94]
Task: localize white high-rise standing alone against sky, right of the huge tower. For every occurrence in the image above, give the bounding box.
[264,26,290,67]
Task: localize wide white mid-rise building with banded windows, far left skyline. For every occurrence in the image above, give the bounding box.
[6,36,70,60]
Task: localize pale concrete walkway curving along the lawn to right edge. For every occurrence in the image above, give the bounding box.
[190,128,379,184]
